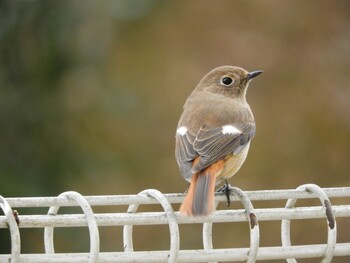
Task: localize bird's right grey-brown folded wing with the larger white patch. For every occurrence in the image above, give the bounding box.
[191,122,255,173]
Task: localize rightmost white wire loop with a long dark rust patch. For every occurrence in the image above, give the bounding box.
[281,184,337,263]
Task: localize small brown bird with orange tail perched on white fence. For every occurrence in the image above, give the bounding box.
[175,66,263,216]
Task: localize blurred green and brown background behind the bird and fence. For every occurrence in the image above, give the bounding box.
[0,0,350,262]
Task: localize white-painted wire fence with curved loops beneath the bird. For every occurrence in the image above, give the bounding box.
[0,184,350,263]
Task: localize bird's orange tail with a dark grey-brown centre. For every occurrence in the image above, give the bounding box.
[180,161,224,216]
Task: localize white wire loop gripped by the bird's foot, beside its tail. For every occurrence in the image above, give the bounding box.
[203,187,260,263]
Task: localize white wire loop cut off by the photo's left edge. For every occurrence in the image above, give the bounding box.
[0,195,21,263]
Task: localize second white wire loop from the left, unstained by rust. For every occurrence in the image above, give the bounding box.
[44,191,100,263]
